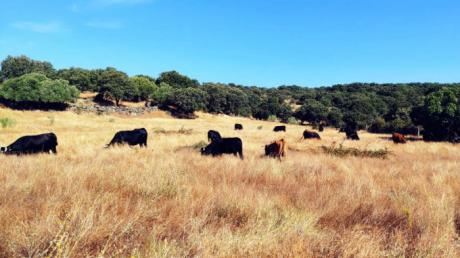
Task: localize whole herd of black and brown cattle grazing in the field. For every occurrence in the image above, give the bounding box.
[0,124,406,159]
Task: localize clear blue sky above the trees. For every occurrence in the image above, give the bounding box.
[0,0,460,87]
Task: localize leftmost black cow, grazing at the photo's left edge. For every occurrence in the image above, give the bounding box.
[0,133,58,155]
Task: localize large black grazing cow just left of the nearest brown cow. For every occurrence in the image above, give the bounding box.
[201,138,243,159]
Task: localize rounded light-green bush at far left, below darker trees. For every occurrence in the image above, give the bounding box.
[0,73,80,103]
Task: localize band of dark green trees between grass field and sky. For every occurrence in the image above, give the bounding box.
[0,56,460,141]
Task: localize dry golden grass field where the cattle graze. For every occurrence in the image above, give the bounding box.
[0,109,460,257]
